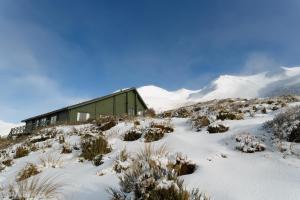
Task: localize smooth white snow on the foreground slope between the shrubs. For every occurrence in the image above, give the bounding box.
[0,103,300,200]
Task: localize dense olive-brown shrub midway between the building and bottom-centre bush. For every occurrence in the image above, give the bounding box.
[81,136,111,161]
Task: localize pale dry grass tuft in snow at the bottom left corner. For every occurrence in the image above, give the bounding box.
[0,176,63,200]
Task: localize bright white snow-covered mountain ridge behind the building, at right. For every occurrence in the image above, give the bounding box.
[138,67,300,112]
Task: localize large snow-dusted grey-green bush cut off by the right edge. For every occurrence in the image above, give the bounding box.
[264,106,300,142]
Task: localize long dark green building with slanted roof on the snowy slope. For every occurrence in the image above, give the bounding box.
[22,88,148,129]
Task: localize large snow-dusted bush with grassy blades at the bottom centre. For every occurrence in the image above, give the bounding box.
[108,145,209,200]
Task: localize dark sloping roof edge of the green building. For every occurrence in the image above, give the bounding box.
[21,87,148,122]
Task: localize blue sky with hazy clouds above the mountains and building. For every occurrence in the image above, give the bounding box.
[0,0,300,122]
